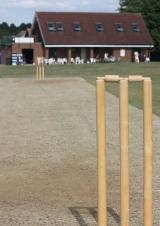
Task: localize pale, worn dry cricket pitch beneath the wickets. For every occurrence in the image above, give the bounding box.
[0,78,160,226]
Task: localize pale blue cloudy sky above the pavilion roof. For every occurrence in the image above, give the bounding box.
[0,0,119,25]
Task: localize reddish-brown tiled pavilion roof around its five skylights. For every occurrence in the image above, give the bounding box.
[33,12,153,45]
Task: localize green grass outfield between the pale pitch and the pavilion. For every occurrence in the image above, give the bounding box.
[0,62,160,116]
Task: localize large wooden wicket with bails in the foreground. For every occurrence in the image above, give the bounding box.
[96,75,152,226]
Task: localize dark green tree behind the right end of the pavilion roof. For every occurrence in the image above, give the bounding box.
[119,0,160,50]
